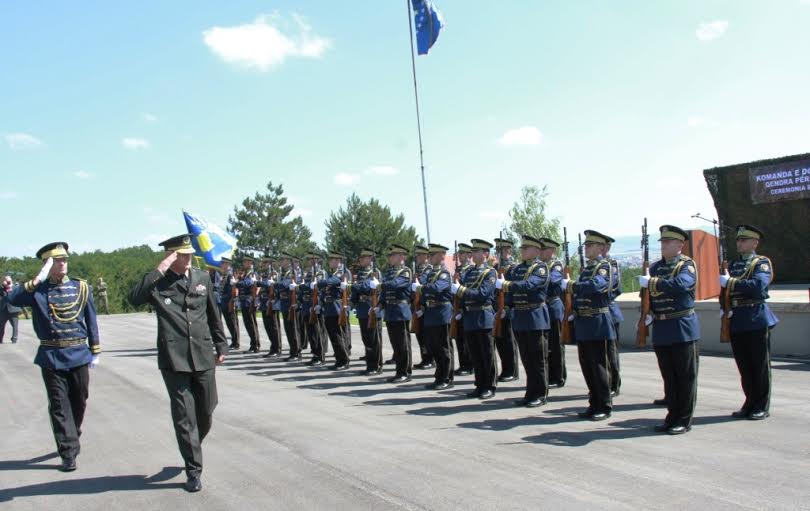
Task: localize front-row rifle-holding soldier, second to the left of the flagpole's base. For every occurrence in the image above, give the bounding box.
[350,248,382,376]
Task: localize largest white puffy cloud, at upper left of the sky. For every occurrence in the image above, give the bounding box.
[203,14,332,72]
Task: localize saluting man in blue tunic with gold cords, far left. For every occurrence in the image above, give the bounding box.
[8,241,101,472]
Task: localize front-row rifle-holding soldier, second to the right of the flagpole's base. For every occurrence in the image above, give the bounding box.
[450,239,498,399]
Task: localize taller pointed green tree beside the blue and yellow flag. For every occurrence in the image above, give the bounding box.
[228,181,315,257]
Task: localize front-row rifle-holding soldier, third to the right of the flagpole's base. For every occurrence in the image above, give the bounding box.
[495,235,551,408]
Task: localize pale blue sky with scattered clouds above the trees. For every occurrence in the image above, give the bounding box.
[0,0,810,256]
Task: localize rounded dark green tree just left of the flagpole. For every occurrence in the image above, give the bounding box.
[324,193,423,261]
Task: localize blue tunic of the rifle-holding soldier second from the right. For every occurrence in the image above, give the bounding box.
[649,255,700,346]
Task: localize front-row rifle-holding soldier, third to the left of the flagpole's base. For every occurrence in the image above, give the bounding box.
[318,252,349,371]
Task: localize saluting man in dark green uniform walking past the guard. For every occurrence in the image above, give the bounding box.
[129,234,228,492]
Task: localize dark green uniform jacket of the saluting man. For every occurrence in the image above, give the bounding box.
[129,268,228,372]
